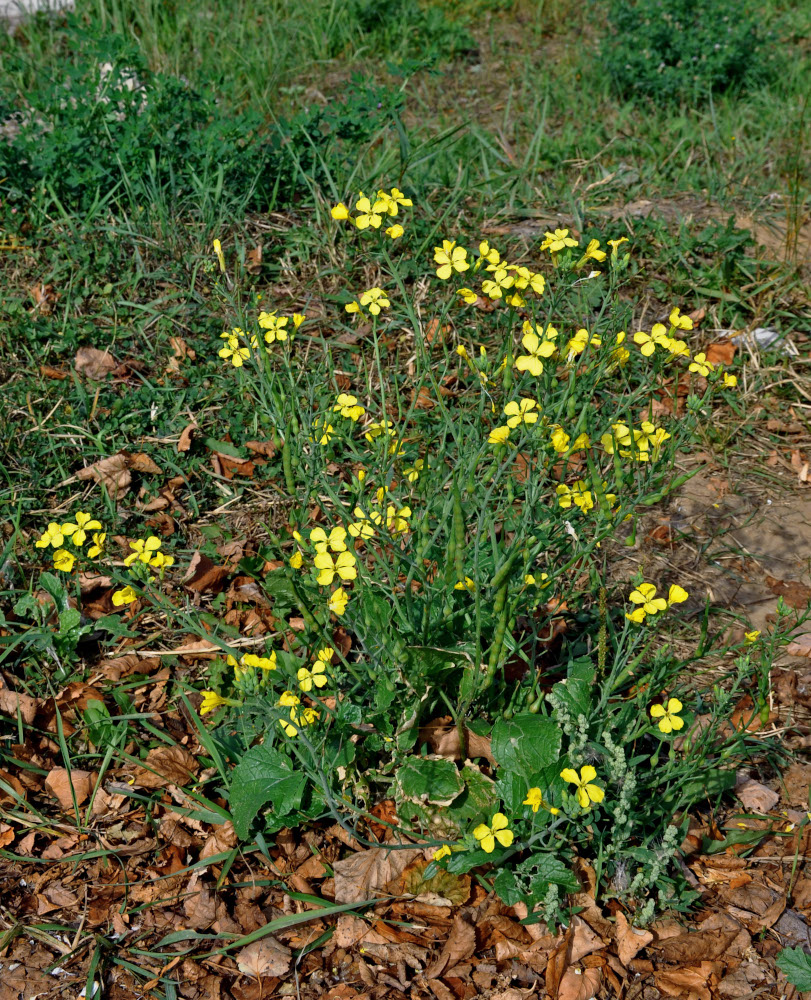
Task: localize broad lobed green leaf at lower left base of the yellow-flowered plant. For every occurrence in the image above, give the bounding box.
[229,745,307,840]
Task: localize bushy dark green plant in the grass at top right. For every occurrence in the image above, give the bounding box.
[601,0,769,101]
